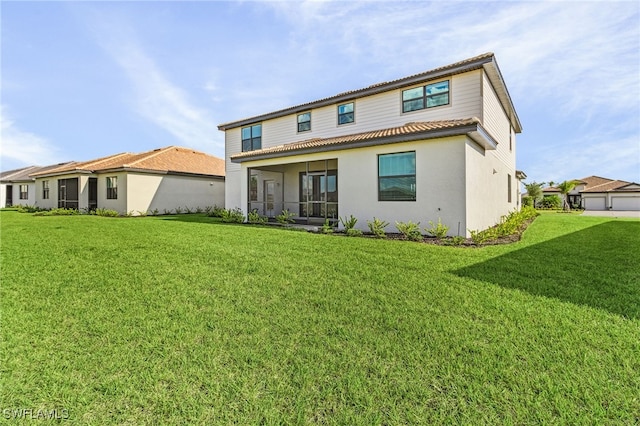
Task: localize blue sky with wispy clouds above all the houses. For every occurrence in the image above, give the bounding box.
[0,1,640,182]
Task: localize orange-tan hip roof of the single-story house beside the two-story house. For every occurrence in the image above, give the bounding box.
[34,146,225,176]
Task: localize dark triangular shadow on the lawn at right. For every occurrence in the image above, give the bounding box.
[454,221,640,319]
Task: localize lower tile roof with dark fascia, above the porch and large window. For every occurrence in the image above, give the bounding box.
[231,117,488,161]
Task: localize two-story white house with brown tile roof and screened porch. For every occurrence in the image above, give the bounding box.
[218,53,521,235]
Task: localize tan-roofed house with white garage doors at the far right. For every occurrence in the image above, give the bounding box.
[542,176,640,211]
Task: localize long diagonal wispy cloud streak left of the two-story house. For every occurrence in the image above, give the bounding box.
[82,10,224,152]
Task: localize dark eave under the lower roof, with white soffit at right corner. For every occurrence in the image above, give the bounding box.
[231,124,498,163]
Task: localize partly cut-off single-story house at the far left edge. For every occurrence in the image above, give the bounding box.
[0,163,73,207]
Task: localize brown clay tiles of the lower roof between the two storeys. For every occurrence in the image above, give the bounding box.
[231,117,480,161]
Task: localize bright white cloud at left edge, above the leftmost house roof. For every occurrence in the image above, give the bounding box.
[0,105,61,169]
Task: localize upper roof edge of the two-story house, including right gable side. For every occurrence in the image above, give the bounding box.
[218,52,522,133]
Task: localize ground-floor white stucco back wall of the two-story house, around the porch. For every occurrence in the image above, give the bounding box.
[232,136,467,235]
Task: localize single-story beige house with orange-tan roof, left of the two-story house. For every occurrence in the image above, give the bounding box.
[33,146,225,215]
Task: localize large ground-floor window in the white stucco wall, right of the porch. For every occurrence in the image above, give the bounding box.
[378,151,416,201]
